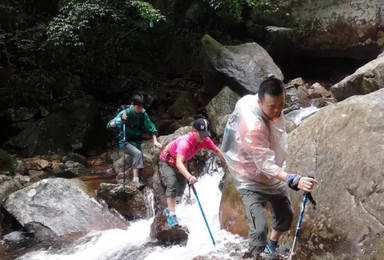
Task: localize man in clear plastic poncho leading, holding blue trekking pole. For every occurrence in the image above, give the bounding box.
[221,77,317,259]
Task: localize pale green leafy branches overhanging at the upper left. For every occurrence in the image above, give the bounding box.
[47,0,165,47]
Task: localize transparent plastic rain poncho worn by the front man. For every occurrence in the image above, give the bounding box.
[221,95,287,194]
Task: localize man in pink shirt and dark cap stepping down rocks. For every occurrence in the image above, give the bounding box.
[159,118,224,227]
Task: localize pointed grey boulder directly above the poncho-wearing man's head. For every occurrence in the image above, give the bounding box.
[202,35,284,96]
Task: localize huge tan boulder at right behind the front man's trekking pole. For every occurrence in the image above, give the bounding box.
[287,89,384,259]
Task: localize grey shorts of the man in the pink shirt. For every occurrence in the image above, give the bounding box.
[159,160,187,197]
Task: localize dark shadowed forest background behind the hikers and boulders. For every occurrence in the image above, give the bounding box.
[0,0,378,154]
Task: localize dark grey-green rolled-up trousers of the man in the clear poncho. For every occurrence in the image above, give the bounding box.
[239,189,293,253]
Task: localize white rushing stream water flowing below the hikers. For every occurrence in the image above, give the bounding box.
[18,172,245,260]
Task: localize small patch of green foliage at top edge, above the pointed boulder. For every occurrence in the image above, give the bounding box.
[203,0,277,24]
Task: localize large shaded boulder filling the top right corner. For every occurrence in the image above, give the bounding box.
[292,0,384,59]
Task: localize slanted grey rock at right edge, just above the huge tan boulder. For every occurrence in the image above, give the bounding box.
[331,56,384,101]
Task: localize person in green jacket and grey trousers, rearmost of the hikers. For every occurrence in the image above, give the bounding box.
[107,95,162,188]
